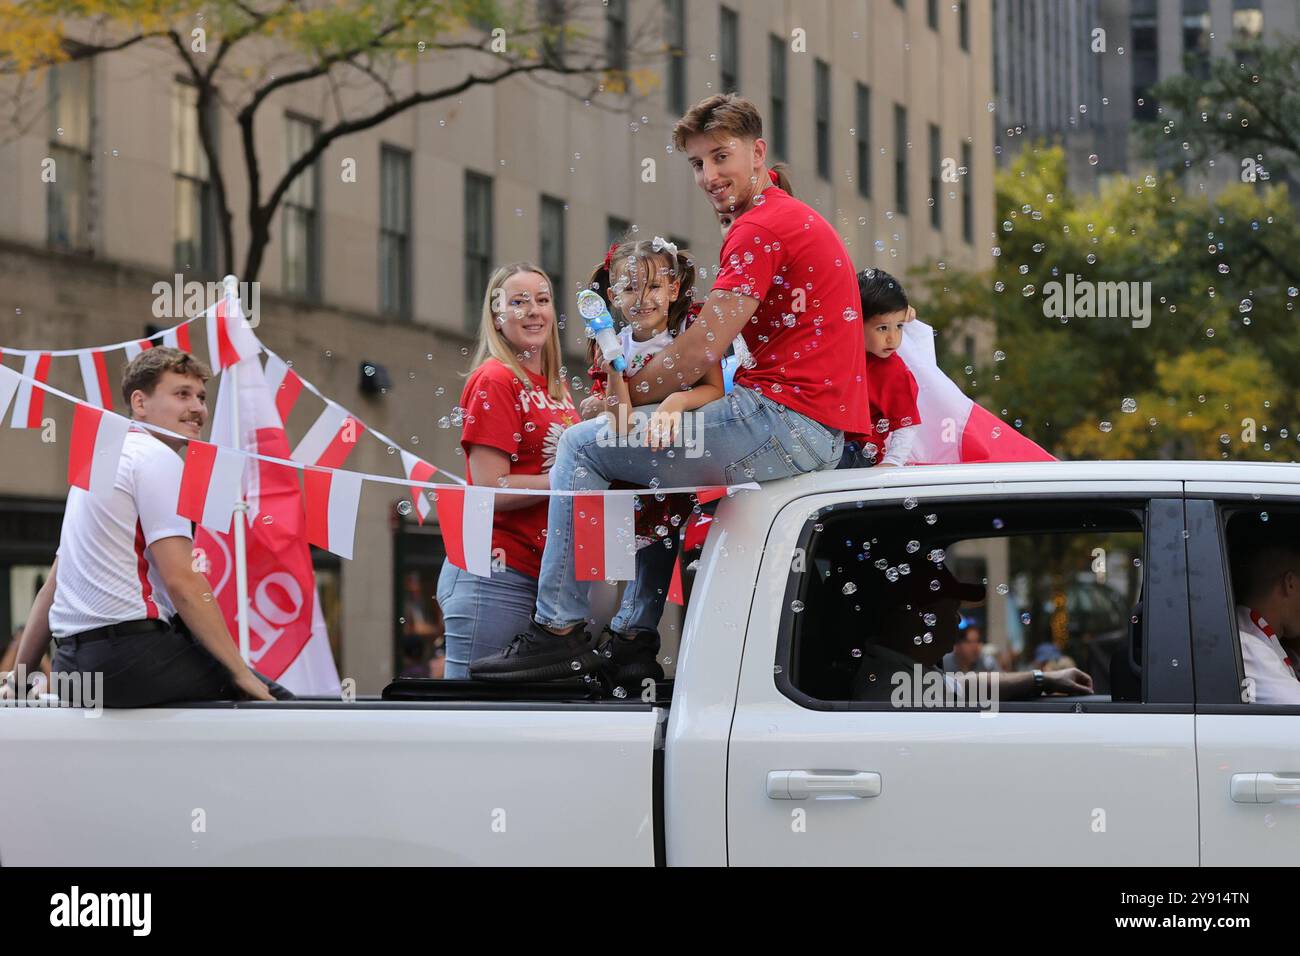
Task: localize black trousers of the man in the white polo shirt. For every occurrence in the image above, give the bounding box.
[49,618,294,708]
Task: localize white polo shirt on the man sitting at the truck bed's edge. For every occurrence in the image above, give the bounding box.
[49,428,192,637]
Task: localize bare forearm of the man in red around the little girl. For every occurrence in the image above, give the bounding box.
[628,289,758,405]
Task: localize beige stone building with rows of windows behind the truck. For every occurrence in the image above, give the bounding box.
[0,0,995,693]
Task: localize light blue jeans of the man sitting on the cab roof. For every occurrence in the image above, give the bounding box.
[535,386,844,632]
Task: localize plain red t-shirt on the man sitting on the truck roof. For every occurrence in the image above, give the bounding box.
[714,186,871,433]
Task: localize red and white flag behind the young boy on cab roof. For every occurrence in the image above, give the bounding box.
[898,319,1057,464]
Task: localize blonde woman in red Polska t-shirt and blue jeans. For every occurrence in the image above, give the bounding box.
[438,263,579,680]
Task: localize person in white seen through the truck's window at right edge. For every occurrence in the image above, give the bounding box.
[1230,515,1300,704]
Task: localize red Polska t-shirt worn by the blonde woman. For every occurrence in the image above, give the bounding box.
[460,359,579,578]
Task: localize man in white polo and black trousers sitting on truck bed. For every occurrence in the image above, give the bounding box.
[3,347,293,708]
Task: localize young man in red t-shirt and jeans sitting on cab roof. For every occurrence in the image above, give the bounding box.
[469,94,871,680]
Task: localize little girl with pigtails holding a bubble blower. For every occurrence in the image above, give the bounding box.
[582,237,723,693]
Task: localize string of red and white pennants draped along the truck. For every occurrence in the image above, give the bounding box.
[0,299,758,580]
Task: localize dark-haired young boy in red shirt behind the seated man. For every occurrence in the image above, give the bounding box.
[840,269,920,468]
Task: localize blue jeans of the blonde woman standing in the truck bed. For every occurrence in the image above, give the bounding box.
[438,561,537,680]
